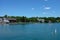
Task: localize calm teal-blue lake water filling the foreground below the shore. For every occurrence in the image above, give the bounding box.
[0,23,60,40]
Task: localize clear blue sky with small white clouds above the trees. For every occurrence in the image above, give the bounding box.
[0,0,60,17]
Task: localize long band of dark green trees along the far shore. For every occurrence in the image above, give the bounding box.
[4,15,60,23]
